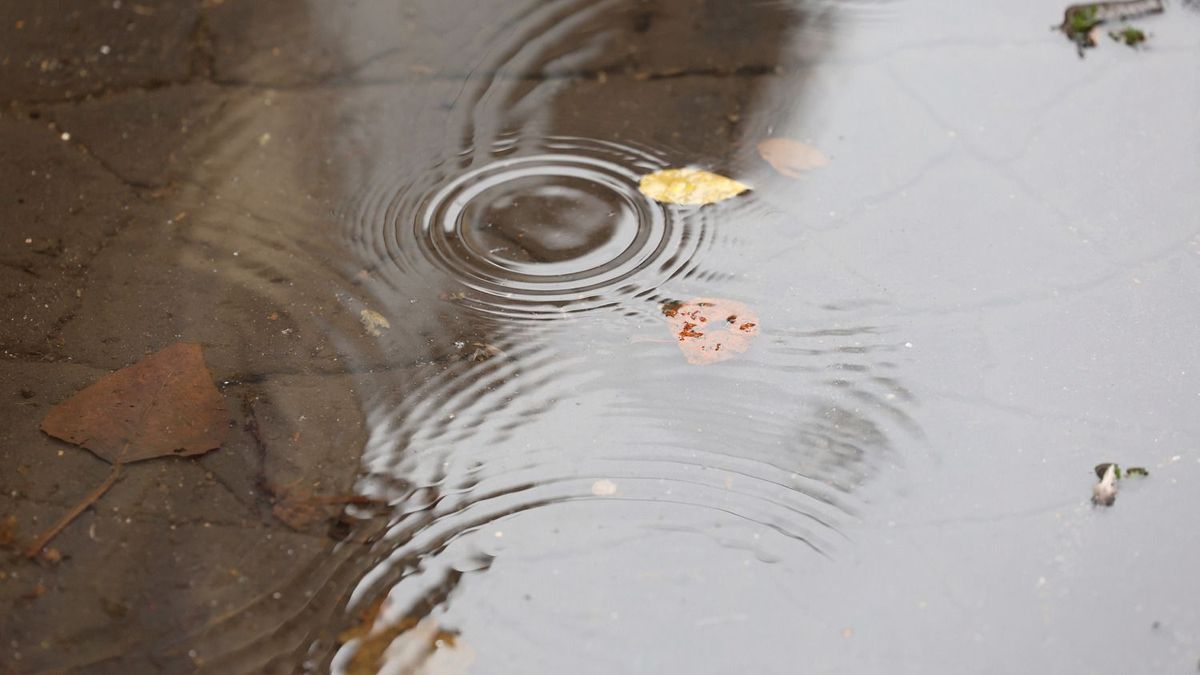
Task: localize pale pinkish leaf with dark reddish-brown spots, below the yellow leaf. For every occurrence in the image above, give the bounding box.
[662,298,758,365]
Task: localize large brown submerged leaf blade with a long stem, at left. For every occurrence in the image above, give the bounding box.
[42,342,229,464]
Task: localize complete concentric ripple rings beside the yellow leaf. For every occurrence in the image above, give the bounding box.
[356,139,710,318]
